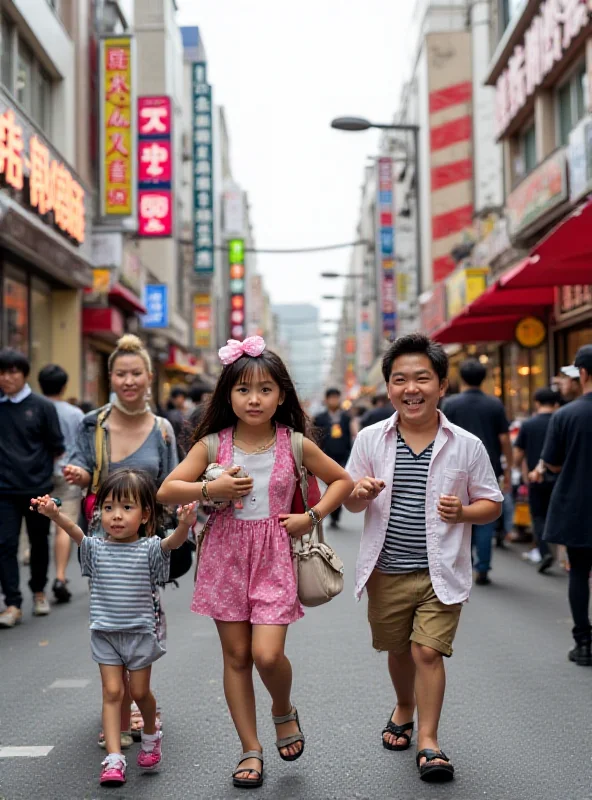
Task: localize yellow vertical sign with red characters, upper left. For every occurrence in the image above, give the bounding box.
[100,36,133,217]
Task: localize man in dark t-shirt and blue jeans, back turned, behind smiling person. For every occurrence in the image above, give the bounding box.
[442,358,513,586]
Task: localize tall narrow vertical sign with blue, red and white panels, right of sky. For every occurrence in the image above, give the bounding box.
[376,158,397,339]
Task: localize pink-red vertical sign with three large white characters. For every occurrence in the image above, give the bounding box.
[138,96,173,237]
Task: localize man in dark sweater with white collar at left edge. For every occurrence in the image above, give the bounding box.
[0,349,64,628]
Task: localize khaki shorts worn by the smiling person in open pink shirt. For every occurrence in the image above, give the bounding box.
[366,569,462,656]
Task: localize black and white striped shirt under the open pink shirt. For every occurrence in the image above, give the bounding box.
[376,430,434,573]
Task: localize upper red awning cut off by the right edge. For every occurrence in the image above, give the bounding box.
[500,201,592,289]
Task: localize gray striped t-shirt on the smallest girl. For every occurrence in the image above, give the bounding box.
[80,536,171,633]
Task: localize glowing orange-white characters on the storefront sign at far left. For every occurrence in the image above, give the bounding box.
[0,101,86,244]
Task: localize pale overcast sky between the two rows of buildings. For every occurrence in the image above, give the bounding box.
[177,0,413,317]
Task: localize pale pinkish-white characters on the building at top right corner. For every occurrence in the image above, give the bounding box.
[496,0,591,137]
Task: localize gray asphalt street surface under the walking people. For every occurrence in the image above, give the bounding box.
[0,515,592,800]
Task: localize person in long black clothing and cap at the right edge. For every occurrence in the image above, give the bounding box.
[532,344,592,666]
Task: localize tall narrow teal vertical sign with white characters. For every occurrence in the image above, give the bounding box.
[192,61,214,274]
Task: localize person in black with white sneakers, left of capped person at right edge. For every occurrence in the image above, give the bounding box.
[514,389,559,573]
